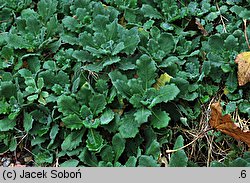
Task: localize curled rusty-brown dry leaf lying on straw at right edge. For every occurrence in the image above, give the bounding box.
[209,102,250,147]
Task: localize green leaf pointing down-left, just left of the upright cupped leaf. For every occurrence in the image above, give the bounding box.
[61,129,85,151]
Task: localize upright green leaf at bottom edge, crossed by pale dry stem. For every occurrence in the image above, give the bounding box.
[169,135,188,167]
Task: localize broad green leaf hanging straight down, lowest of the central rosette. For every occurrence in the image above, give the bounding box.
[119,114,140,138]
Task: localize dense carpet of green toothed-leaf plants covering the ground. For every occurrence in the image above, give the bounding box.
[0,0,250,167]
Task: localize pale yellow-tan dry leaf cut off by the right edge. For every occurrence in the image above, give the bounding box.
[235,52,250,86]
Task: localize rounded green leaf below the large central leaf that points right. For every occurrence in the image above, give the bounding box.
[151,110,171,129]
